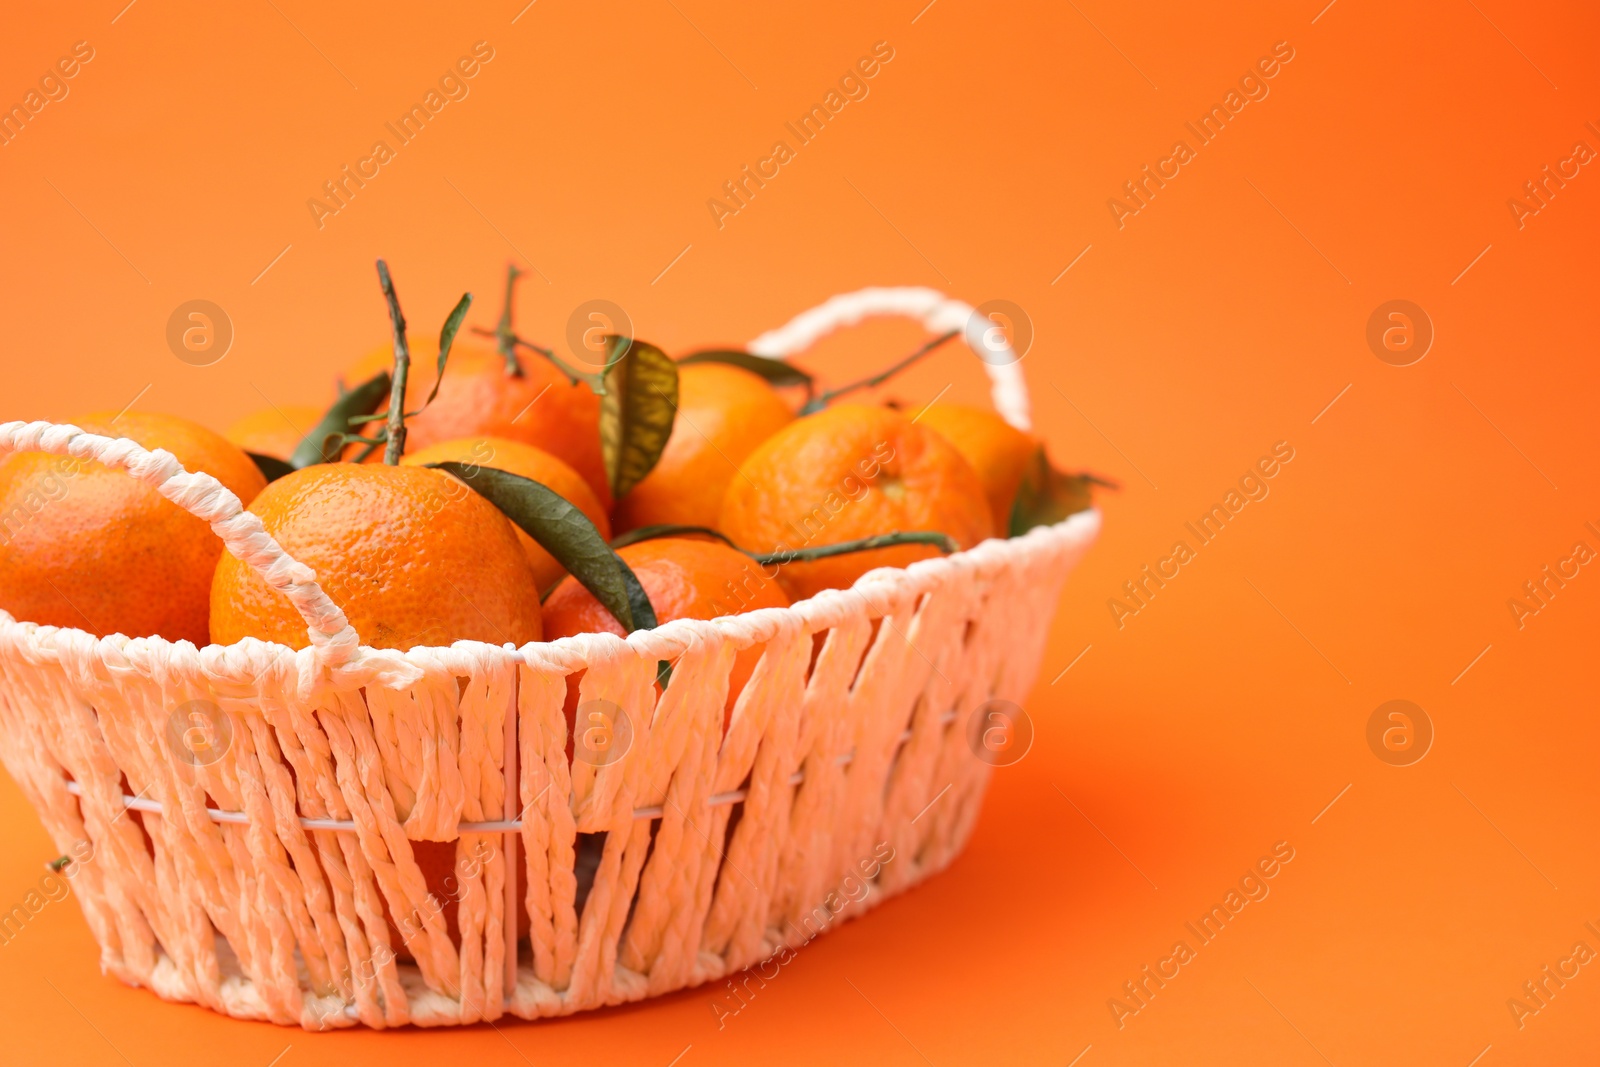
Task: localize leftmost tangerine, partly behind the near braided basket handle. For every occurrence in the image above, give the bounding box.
[0,411,266,645]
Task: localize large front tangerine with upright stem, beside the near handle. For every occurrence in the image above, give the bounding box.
[211,464,542,649]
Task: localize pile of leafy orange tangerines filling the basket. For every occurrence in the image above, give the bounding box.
[0,262,1106,668]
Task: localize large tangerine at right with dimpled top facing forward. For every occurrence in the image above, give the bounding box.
[717,403,994,600]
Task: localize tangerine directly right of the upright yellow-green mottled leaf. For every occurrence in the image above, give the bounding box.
[616,363,795,530]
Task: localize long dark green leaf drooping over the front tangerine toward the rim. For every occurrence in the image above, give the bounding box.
[427,462,656,633]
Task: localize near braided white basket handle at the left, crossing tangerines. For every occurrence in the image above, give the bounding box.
[0,422,360,667]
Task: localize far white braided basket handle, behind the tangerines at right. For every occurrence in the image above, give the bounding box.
[749,286,1032,430]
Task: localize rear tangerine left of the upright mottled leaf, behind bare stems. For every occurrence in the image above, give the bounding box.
[346,338,611,507]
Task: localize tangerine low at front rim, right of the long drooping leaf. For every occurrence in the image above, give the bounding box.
[544,537,789,729]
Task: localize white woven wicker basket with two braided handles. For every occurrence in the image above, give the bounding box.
[0,290,1099,1029]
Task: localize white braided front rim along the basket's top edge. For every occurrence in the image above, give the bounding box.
[0,507,1102,683]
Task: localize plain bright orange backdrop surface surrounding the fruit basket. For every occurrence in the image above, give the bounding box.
[0,0,1600,1067]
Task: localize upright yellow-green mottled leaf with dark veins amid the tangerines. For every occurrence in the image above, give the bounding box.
[597,334,678,499]
